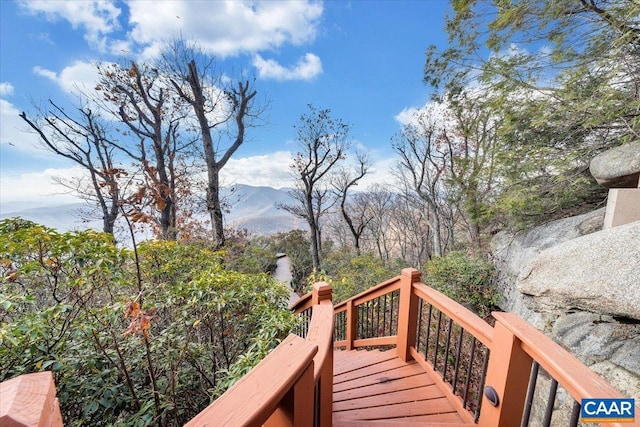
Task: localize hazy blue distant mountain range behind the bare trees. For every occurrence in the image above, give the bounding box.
[0,184,306,235]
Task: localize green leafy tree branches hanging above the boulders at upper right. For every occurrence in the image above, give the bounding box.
[424,0,640,226]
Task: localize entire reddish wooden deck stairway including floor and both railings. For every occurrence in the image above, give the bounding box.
[0,269,640,427]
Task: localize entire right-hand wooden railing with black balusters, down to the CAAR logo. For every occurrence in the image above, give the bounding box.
[334,269,640,427]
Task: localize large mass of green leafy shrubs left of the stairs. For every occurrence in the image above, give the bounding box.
[0,219,295,426]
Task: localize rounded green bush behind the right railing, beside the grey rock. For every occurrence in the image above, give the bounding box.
[422,252,499,316]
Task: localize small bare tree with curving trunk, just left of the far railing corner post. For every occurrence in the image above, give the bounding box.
[332,154,372,255]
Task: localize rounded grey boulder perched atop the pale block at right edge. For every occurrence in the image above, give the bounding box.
[589,141,640,188]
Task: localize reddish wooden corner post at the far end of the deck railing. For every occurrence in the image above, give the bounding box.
[396,268,421,362]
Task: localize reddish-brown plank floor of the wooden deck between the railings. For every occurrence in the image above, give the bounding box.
[333,349,474,427]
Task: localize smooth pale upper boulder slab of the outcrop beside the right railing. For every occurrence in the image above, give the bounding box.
[517,221,640,320]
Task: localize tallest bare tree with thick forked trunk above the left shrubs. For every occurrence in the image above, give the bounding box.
[164,41,262,247]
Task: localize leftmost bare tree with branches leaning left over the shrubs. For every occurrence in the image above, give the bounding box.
[20,100,122,234]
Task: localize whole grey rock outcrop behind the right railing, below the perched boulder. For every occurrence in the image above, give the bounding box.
[492,209,640,399]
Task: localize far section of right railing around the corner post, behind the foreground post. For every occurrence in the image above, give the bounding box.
[334,268,493,422]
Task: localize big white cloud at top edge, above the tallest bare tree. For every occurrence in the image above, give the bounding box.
[128,0,323,57]
